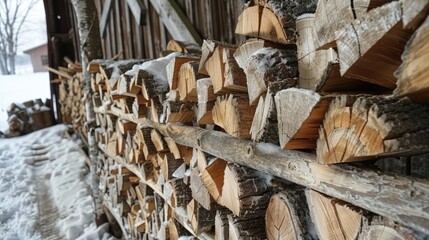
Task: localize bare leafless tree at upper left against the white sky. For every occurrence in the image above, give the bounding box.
[0,0,39,75]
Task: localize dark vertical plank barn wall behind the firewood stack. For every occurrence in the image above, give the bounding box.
[94,0,245,59]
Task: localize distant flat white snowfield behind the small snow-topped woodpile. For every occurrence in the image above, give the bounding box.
[0,72,50,131]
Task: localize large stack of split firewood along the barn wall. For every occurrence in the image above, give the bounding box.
[56,0,429,239]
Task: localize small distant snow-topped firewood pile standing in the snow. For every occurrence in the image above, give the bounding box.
[4,99,54,137]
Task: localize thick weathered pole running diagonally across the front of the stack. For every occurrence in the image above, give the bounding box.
[139,120,429,234]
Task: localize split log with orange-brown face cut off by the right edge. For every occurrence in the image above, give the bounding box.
[394,15,429,103]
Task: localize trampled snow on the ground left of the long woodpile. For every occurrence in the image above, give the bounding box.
[0,125,113,240]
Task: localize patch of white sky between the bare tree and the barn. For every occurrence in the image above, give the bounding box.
[16,0,47,54]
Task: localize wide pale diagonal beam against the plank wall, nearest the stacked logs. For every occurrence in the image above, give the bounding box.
[149,0,203,45]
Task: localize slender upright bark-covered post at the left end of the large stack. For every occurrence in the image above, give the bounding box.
[71,0,103,220]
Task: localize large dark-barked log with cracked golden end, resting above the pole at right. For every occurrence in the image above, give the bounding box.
[317,96,429,164]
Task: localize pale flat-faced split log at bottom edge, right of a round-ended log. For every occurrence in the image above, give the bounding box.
[305,190,362,240]
